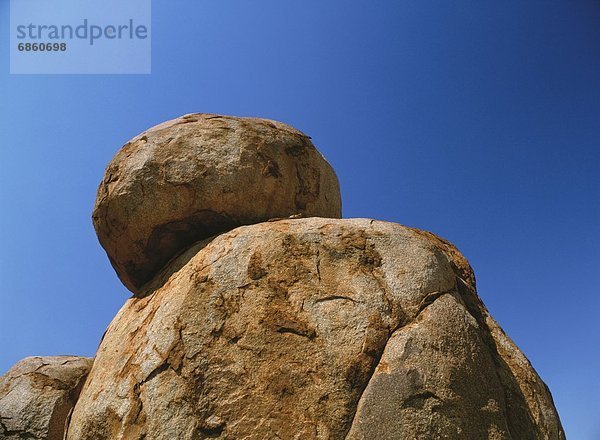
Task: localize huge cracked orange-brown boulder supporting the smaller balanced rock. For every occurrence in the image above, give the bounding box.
[68,218,564,440]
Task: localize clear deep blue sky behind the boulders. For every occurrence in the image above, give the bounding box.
[0,0,600,440]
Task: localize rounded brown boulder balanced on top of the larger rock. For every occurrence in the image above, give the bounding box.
[93,114,341,294]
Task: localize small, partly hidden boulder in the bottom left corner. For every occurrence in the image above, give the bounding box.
[0,356,93,440]
